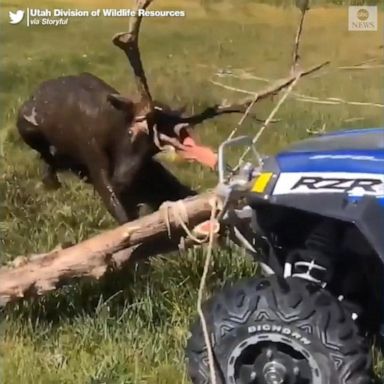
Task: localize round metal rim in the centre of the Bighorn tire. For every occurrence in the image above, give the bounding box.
[227,333,323,384]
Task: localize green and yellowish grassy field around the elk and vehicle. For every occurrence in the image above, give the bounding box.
[0,0,384,384]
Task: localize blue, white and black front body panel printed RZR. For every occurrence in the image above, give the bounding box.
[248,128,384,264]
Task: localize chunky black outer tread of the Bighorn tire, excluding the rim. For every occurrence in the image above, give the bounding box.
[186,276,372,384]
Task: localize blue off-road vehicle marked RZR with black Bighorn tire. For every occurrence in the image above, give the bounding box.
[186,128,384,384]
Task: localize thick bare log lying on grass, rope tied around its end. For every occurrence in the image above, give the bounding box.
[0,192,219,307]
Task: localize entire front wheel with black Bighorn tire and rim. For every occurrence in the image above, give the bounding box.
[186,276,372,384]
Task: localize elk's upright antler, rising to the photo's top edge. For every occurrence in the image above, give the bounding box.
[112,0,153,115]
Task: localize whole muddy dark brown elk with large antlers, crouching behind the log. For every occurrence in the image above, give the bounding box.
[17,0,328,224]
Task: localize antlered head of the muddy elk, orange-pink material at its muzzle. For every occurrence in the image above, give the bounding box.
[108,0,256,168]
